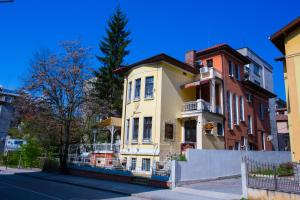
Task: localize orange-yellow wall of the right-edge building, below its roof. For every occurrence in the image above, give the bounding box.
[284,28,300,161]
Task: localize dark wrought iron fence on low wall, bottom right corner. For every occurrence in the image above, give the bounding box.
[245,159,300,194]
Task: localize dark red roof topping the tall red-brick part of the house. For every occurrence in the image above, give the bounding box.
[196,44,251,64]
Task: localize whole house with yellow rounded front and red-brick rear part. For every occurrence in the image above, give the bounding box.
[115,44,274,173]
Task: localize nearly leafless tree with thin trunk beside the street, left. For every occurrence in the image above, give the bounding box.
[24,41,90,172]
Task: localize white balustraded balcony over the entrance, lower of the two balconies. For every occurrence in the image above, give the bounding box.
[183,99,223,114]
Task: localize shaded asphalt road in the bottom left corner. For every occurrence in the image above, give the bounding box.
[0,175,141,200]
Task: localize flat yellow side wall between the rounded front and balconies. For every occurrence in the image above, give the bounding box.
[160,64,196,160]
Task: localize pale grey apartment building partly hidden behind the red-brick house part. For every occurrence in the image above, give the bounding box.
[237,47,278,150]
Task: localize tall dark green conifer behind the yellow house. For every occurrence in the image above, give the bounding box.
[95,7,131,117]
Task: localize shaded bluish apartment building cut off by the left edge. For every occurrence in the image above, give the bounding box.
[0,86,18,152]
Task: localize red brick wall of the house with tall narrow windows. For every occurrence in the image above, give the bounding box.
[197,51,272,150]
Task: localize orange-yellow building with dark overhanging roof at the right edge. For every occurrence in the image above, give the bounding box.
[270,17,300,162]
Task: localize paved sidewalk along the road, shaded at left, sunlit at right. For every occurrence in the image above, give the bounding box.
[16,172,240,200]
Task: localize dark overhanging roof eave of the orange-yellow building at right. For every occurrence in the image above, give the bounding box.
[269,16,300,54]
